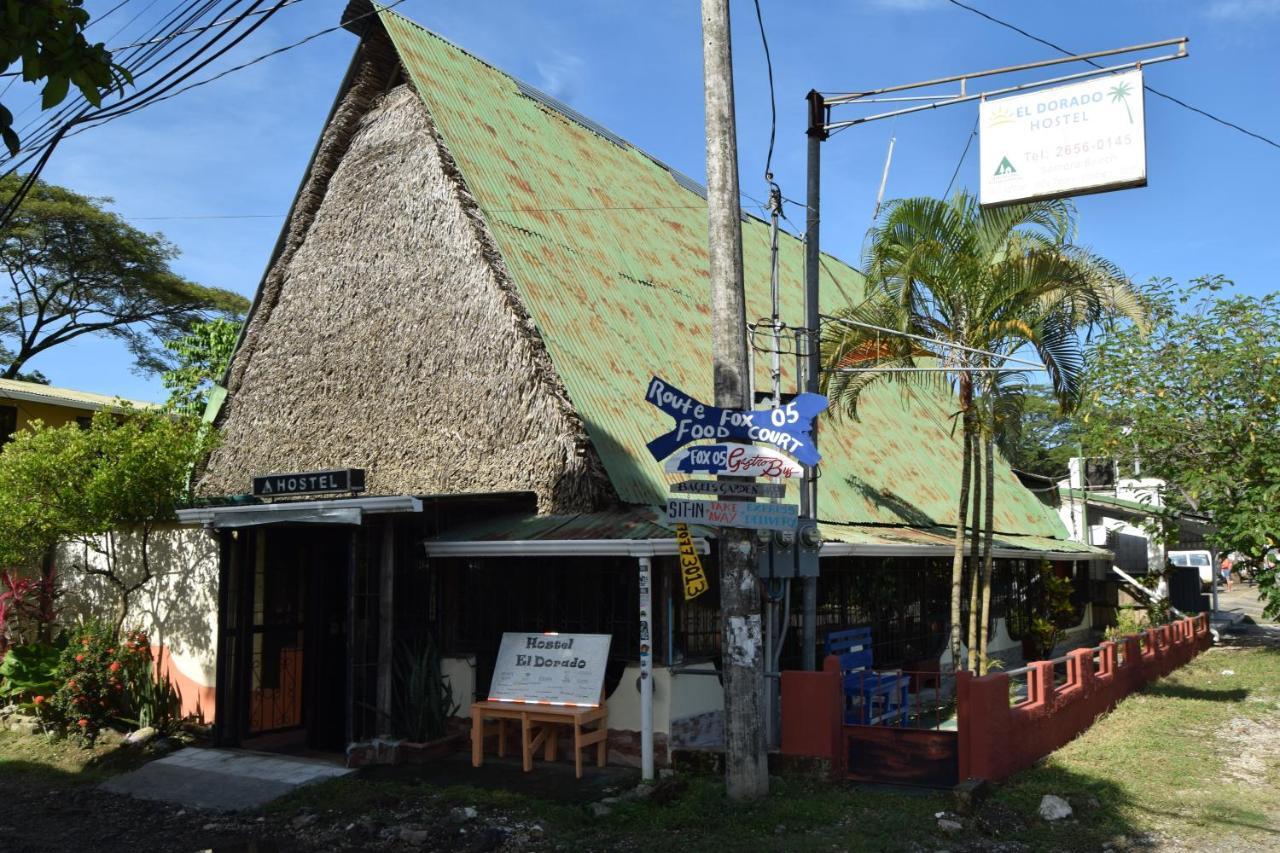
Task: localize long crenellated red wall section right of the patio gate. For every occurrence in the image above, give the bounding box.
[956,613,1212,780]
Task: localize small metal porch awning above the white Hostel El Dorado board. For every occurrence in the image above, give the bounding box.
[424,507,709,557]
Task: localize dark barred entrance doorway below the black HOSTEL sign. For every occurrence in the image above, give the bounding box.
[223,526,355,751]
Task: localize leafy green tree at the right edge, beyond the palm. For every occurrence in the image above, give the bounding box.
[1082,275,1280,617]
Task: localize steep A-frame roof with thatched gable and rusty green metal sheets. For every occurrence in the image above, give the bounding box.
[206,6,1065,537]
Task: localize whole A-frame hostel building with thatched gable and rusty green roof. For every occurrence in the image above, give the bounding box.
[167,4,1098,758]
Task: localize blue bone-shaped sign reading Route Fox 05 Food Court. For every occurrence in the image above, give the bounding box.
[645,377,827,466]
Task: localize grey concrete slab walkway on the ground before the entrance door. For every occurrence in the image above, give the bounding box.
[102,747,352,812]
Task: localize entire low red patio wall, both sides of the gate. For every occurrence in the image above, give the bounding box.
[782,613,1212,781]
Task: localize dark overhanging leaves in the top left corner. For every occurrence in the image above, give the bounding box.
[0,0,133,155]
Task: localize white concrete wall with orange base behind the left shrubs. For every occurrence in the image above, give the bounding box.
[58,525,218,721]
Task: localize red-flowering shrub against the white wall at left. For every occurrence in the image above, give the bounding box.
[49,622,151,745]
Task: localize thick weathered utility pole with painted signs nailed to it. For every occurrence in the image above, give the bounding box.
[703,0,769,800]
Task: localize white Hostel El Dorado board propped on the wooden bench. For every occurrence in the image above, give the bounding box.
[489,633,612,708]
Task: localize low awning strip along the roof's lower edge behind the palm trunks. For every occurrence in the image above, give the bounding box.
[818,523,1112,561]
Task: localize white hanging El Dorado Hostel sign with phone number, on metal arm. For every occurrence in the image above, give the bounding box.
[978,69,1147,206]
